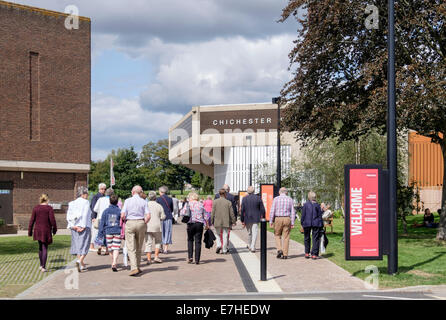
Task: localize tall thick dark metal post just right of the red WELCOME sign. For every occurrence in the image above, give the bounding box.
[387,0,398,274]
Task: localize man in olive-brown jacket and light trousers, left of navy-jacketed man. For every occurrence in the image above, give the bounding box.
[211,189,236,254]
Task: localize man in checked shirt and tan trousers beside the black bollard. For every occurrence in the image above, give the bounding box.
[269,188,296,259]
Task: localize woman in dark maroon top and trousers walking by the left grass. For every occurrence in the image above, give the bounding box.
[28,194,57,272]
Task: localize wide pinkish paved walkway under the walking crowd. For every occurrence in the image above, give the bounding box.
[17,222,365,299]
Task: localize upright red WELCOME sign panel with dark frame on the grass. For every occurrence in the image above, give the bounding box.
[345,165,386,260]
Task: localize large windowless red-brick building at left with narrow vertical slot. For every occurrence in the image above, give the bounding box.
[0,1,91,229]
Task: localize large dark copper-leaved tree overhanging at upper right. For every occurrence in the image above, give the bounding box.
[281,0,446,240]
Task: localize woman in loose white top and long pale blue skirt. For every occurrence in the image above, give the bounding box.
[67,187,91,272]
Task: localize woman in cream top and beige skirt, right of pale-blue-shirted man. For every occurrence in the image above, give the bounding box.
[144,191,166,264]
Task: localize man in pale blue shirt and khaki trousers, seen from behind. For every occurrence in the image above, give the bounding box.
[121,186,150,276]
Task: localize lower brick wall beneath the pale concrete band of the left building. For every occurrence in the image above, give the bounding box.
[0,171,87,229]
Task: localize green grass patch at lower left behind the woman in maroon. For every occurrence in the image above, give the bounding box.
[0,235,73,298]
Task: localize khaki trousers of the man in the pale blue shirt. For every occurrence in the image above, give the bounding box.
[125,220,146,270]
